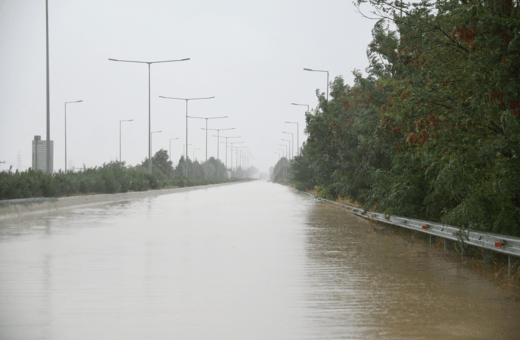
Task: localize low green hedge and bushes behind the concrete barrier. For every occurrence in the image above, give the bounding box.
[0,150,254,200]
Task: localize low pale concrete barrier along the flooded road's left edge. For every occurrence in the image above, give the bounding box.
[0,182,240,221]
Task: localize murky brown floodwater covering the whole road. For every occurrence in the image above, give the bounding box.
[0,181,520,340]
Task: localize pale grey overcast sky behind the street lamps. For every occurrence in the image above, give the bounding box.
[0,0,374,175]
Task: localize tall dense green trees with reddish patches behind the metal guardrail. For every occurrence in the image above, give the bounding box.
[291,0,520,236]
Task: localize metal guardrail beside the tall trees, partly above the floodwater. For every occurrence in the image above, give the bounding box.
[306,192,520,267]
